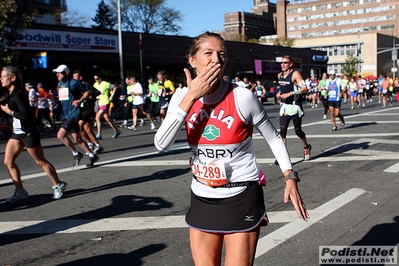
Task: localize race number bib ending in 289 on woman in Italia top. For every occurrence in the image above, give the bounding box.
[190,159,228,187]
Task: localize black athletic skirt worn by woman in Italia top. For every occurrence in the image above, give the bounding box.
[186,184,268,233]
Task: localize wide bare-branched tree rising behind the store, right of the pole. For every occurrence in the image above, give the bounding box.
[111,0,182,34]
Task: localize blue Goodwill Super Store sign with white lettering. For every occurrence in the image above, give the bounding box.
[11,29,119,53]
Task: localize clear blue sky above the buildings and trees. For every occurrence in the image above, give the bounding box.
[66,0,266,37]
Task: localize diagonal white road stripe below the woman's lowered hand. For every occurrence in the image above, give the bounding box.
[255,188,366,258]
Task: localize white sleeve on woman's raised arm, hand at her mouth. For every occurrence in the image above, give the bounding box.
[154,89,187,151]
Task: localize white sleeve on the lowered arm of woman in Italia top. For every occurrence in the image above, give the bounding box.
[235,87,292,172]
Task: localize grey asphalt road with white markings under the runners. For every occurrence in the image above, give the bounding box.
[0,98,399,266]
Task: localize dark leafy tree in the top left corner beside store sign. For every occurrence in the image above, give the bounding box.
[0,0,32,66]
